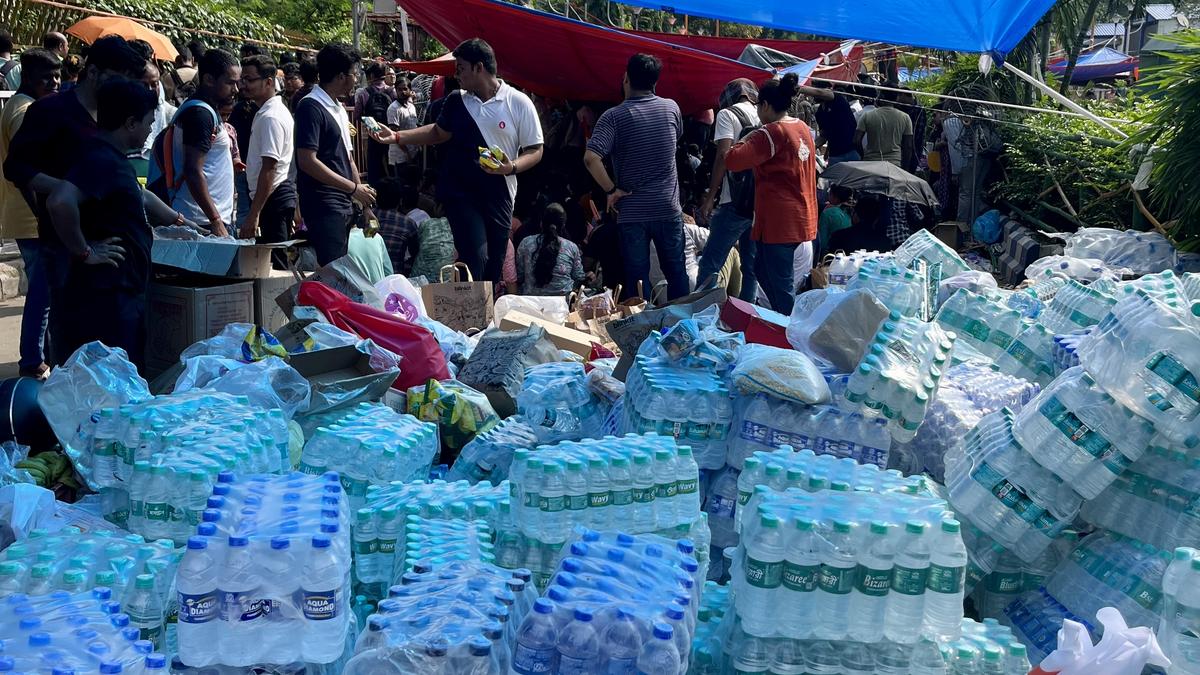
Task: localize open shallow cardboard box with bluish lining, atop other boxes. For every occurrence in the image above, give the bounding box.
[150,239,296,279]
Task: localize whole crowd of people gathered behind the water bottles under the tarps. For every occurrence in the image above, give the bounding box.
[0,24,980,376]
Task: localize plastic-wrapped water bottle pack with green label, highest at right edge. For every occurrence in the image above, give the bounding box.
[1078,291,1200,447]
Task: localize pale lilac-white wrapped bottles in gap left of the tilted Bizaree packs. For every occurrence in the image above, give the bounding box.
[889,362,1039,482]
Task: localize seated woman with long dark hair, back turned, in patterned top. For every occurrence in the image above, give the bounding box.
[517,204,583,295]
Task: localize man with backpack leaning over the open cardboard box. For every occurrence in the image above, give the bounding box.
[150,49,241,237]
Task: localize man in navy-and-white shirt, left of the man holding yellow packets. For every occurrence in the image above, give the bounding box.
[295,44,376,265]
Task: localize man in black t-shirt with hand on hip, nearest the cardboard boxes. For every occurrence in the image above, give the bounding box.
[46,79,201,366]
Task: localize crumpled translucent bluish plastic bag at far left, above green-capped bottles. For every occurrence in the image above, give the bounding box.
[37,341,151,466]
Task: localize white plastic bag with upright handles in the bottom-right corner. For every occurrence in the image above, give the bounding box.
[1040,607,1171,675]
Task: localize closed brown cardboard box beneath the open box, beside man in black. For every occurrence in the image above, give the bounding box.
[146,280,254,372]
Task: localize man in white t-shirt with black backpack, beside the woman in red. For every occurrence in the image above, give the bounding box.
[696,78,762,303]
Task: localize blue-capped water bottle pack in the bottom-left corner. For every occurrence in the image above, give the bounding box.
[0,586,168,675]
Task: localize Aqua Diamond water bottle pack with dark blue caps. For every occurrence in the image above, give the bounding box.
[175,472,353,667]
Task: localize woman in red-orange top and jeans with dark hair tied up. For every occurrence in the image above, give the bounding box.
[725,73,817,316]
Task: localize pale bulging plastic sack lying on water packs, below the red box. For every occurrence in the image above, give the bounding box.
[733,345,829,406]
